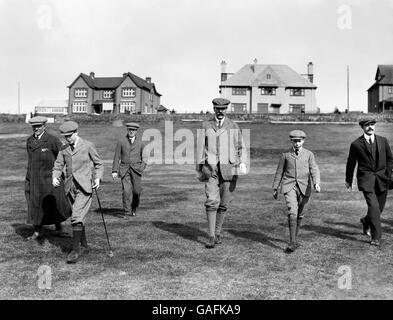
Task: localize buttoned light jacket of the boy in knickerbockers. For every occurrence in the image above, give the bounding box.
[273,148,321,197]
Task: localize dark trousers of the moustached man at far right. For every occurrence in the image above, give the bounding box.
[363,187,388,240]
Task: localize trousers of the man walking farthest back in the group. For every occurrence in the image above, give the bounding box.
[121,168,142,212]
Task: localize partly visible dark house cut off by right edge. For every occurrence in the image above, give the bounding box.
[367,64,393,113]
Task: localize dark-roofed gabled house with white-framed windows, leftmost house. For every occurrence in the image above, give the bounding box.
[68,72,161,114]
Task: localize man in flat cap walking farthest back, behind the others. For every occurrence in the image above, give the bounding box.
[112,122,147,218]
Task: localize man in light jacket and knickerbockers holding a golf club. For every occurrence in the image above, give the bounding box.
[52,121,104,263]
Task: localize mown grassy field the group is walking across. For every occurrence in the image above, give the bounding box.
[0,122,393,300]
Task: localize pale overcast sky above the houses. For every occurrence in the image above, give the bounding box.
[0,0,393,113]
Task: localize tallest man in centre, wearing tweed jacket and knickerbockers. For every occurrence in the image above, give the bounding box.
[196,98,247,249]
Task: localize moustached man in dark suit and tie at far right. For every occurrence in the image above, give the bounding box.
[345,117,393,246]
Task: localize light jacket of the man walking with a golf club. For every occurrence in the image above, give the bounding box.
[52,137,104,194]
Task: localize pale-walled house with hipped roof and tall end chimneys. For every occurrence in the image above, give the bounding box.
[220,59,318,113]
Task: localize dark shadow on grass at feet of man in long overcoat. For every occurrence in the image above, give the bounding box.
[12,223,72,252]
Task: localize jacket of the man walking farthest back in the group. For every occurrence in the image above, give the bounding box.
[112,135,147,178]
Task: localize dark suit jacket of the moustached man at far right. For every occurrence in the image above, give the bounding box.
[345,135,393,192]
